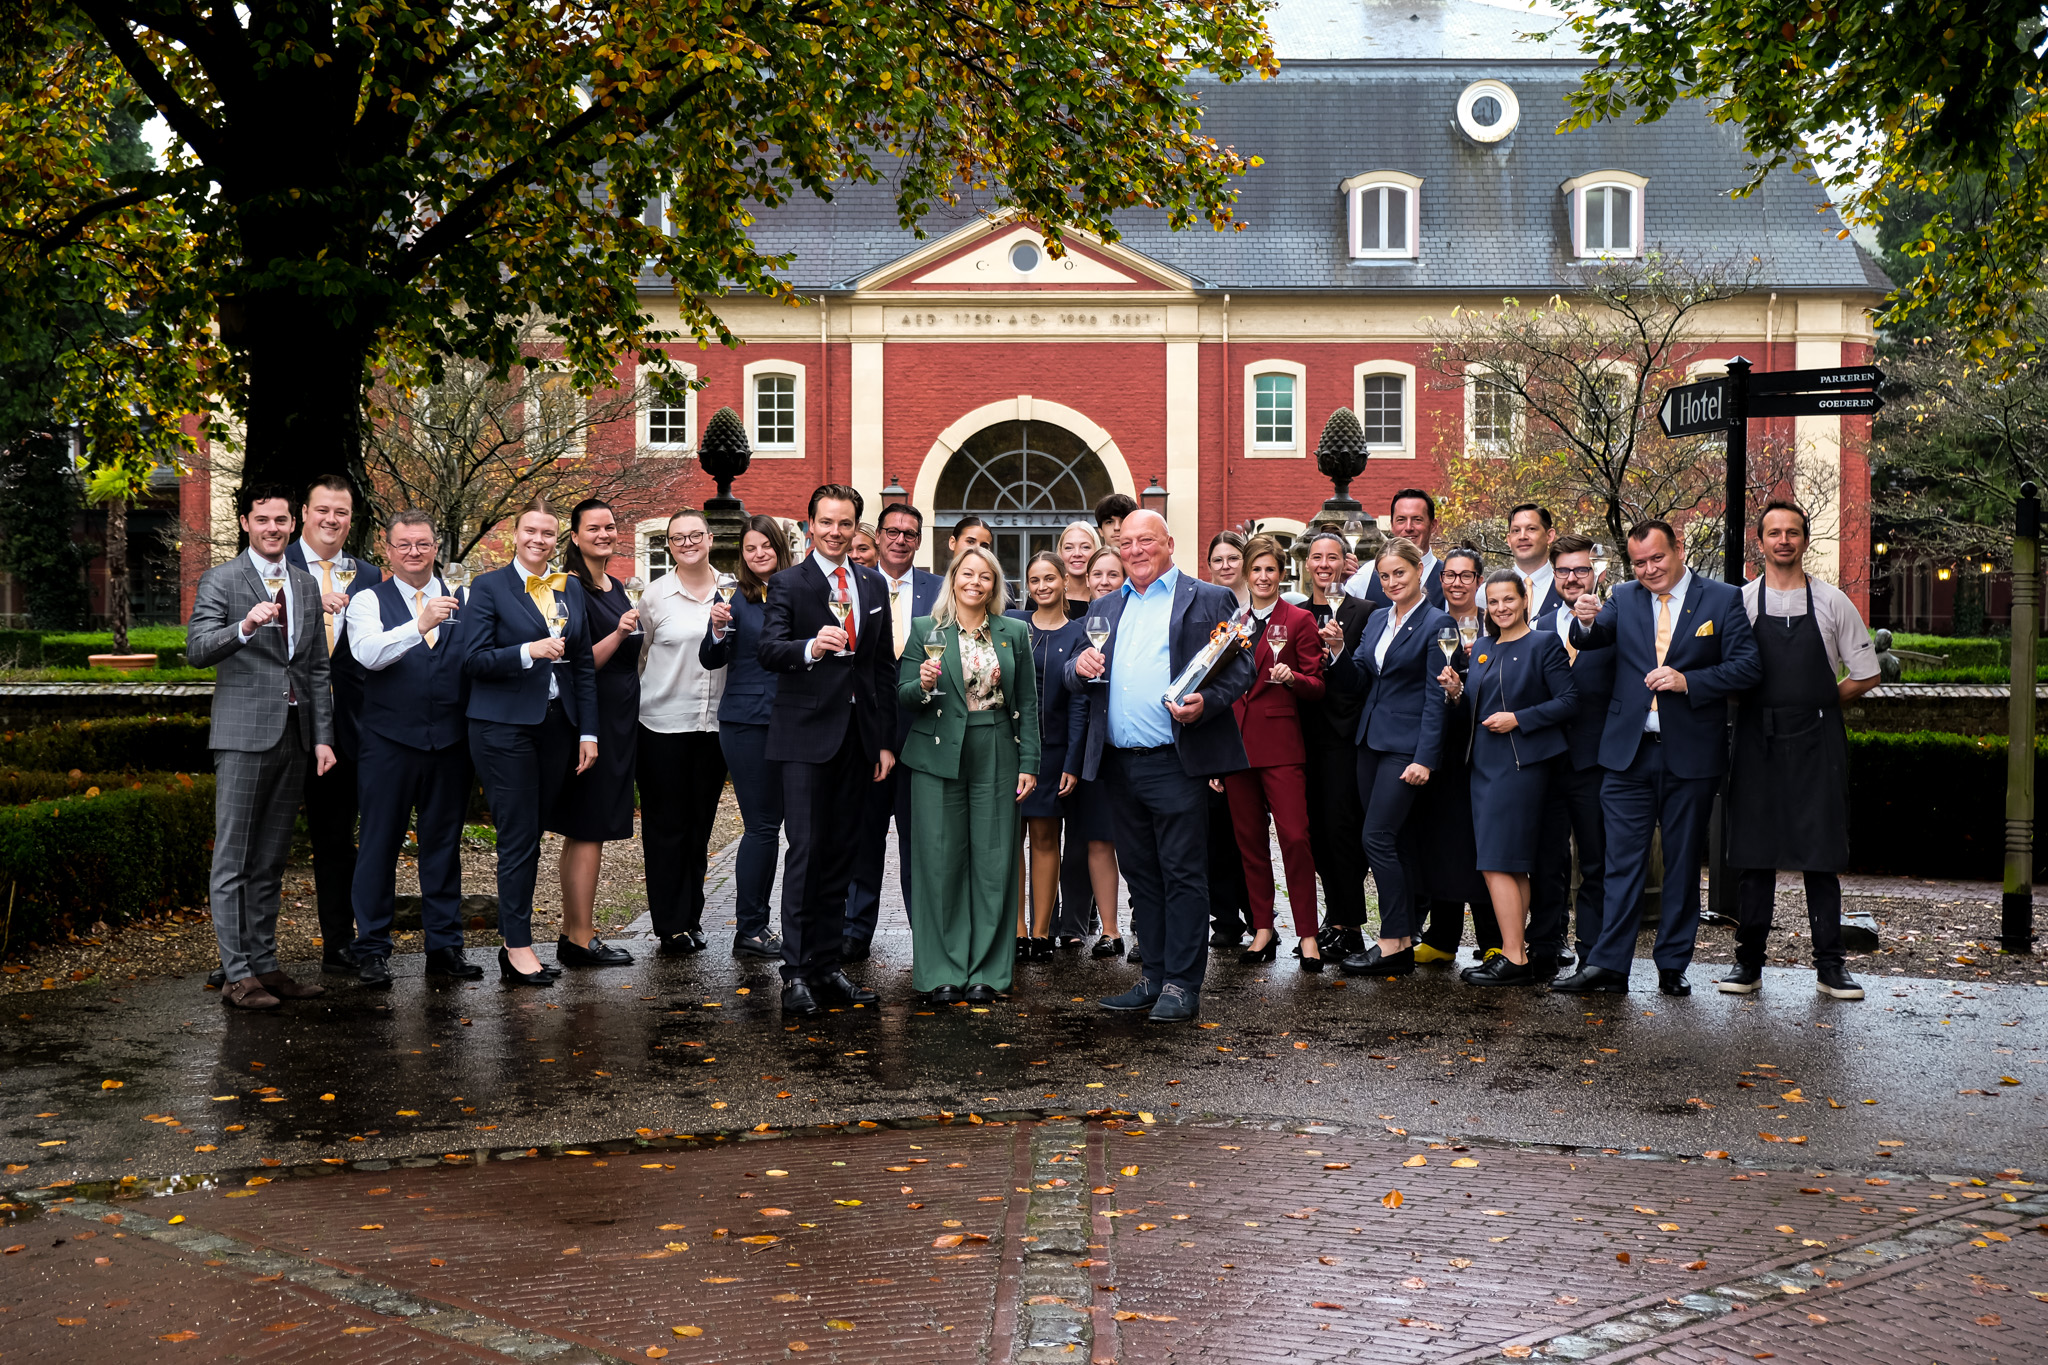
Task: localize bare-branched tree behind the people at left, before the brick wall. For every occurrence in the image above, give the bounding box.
[365,331,676,561]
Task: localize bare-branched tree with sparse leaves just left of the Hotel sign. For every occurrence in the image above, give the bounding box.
[1430,252,1833,571]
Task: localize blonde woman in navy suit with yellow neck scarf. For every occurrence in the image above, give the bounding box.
[461,497,598,986]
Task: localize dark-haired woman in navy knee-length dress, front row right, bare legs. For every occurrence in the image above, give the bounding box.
[1458,569,1579,986]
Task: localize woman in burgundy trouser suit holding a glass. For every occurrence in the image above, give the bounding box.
[1219,536,1323,972]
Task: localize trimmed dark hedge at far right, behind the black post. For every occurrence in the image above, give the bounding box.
[1849,731,2048,882]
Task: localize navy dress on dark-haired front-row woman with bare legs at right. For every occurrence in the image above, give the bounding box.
[1464,630,1579,874]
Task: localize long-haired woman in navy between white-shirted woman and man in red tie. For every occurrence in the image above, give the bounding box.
[696,516,791,962]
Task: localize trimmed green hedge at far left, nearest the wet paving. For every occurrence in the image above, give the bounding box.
[0,774,213,950]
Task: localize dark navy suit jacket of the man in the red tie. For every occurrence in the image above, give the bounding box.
[754,555,897,763]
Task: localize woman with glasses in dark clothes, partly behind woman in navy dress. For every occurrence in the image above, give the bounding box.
[1415,544,1501,962]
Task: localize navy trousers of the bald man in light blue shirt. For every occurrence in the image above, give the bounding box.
[1102,745,1208,993]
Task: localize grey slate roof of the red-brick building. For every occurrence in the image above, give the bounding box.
[663,0,1886,295]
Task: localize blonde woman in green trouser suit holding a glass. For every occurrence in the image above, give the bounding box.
[897,546,1038,1005]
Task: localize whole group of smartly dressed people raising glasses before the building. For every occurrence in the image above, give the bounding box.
[188,479,1878,1021]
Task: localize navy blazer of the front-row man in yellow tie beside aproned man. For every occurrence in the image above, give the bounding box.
[1571,573,1763,778]
